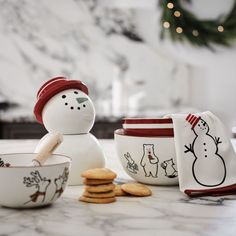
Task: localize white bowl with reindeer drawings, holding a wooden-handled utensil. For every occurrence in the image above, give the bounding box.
[0,153,71,208]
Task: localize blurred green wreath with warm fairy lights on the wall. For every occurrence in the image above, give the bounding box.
[160,0,236,49]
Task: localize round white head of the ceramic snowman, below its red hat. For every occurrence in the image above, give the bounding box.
[42,89,95,134]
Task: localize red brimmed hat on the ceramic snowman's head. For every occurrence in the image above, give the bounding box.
[34,76,88,124]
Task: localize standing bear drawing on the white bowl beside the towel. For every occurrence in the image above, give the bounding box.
[140,144,159,178]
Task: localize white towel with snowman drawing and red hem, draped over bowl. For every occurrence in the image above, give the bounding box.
[171,112,236,197]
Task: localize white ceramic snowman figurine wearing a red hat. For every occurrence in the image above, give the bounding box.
[34,77,105,185]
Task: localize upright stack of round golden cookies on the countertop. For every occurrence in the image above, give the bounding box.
[79,168,116,203]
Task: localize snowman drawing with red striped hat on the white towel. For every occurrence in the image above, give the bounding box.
[185,114,226,187]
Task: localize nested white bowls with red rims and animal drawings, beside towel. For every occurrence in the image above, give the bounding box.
[114,118,178,185]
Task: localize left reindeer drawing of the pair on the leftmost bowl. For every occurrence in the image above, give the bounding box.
[23,170,51,204]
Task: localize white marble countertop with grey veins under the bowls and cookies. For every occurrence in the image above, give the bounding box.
[0,140,236,236]
